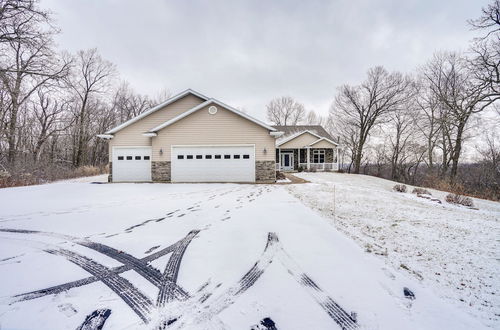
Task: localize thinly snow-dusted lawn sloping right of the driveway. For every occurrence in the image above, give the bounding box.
[287,173,500,329]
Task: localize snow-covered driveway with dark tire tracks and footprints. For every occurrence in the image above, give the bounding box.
[0,180,482,329]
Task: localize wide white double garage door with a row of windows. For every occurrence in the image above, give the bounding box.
[172,146,255,182]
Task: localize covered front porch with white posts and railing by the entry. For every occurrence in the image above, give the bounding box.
[276,147,339,172]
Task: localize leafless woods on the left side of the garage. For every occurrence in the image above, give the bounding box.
[0,0,168,185]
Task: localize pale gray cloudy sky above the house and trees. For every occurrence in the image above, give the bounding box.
[41,0,489,119]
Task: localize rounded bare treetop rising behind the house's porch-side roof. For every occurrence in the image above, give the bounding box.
[267,96,306,126]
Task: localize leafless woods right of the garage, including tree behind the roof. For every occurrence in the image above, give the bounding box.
[267,0,500,199]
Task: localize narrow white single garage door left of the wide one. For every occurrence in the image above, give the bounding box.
[112,147,151,182]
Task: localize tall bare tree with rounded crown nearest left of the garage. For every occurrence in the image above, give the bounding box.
[67,48,116,166]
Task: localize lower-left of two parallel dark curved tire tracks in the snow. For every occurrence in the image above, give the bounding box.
[45,249,153,323]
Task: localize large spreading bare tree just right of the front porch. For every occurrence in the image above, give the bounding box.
[330,67,412,173]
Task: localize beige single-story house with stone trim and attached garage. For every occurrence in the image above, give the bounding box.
[98,89,337,182]
